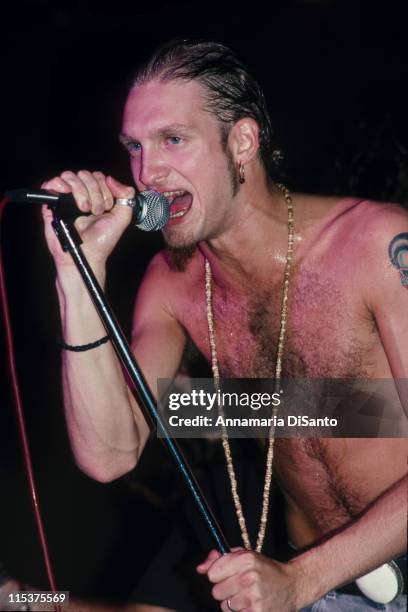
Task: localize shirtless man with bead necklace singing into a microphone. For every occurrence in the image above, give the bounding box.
[39,43,408,612]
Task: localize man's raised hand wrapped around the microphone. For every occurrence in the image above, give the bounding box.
[41,170,135,266]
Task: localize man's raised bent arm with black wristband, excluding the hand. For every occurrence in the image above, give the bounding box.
[58,250,185,481]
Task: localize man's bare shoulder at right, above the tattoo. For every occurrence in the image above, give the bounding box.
[295,196,408,301]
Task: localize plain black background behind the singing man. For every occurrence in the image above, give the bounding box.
[0,0,408,597]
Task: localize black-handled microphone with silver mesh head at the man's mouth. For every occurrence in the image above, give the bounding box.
[5,189,170,232]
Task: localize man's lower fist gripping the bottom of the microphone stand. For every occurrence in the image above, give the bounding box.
[197,549,297,612]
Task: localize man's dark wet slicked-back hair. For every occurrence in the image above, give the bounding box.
[132,39,281,179]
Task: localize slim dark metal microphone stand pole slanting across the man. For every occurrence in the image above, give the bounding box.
[48,209,230,554]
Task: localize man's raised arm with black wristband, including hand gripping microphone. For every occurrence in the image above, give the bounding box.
[43,173,184,481]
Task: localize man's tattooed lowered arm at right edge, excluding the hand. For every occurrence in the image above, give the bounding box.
[294,205,408,601]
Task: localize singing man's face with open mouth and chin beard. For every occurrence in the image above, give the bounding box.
[121,80,235,249]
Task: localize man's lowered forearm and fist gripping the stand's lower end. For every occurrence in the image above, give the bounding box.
[197,477,407,612]
